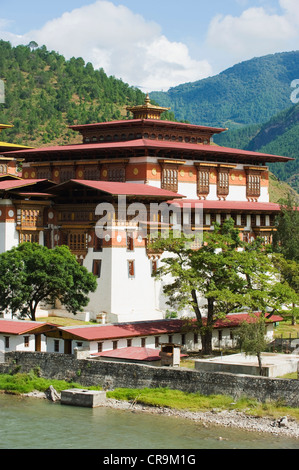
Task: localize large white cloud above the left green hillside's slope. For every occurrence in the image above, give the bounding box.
[0,0,211,91]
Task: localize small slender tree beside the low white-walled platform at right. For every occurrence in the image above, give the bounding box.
[235,315,267,375]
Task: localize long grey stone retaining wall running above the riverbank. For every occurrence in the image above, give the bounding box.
[0,352,299,407]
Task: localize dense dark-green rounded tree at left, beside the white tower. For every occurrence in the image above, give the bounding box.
[0,243,97,321]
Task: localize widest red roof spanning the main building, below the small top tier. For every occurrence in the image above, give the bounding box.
[4,139,294,162]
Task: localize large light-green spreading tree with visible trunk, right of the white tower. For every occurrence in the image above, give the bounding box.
[152,219,287,354]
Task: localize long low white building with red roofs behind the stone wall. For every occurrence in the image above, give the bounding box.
[0,314,282,354]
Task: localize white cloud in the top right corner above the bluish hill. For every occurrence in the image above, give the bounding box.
[206,0,299,69]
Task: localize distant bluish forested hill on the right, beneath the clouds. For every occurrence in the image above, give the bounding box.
[150,51,299,129]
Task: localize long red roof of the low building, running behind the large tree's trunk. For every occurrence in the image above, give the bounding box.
[59,313,282,341]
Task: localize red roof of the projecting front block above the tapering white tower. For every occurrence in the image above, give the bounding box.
[51,180,184,198]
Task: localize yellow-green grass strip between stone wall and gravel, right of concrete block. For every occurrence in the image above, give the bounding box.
[107,388,299,421]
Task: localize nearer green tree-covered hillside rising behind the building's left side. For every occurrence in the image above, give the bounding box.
[0,41,145,146]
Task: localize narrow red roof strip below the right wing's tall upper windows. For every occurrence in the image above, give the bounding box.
[167,199,281,212]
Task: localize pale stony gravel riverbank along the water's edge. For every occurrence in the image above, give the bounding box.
[25,392,299,439]
